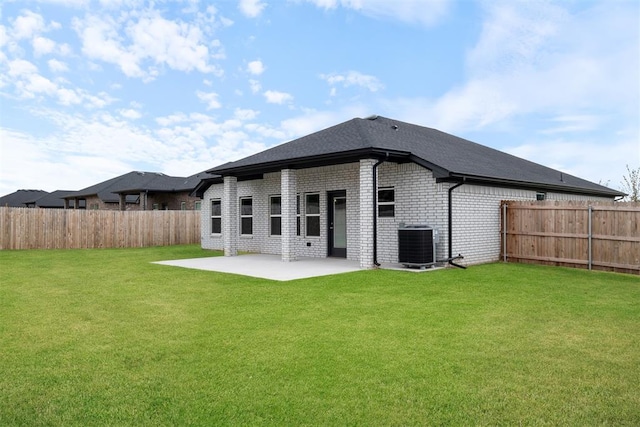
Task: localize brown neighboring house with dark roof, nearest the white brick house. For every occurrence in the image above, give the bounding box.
[64,171,207,210]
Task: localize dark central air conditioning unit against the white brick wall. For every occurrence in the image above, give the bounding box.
[398,224,438,268]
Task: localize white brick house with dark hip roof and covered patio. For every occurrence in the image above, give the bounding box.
[196,117,621,268]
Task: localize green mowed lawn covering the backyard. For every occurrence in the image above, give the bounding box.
[0,246,640,426]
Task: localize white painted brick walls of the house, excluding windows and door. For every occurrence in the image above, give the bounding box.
[202,160,612,264]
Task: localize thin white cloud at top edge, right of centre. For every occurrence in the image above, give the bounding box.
[307,0,452,26]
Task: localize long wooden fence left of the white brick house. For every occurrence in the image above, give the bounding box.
[0,207,200,249]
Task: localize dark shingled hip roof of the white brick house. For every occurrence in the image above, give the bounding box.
[207,116,624,197]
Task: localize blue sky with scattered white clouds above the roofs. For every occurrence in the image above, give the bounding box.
[0,0,640,195]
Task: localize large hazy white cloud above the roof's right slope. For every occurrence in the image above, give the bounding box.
[384,2,640,133]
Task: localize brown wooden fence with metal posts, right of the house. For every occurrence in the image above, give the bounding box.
[501,201,640,274]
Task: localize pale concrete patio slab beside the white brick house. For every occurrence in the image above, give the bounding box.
[154,254,439,281]
